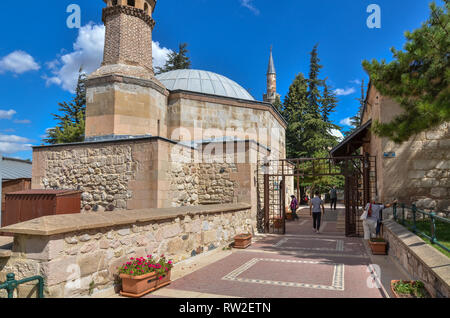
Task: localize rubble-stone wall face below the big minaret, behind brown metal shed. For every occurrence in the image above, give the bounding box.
[33,143,142,209]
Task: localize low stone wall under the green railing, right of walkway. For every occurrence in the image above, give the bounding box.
[384,220,450,298]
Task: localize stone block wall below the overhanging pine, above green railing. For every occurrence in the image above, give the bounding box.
[382,123,450,213]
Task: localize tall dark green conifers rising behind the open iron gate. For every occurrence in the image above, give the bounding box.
[282,45,344,194]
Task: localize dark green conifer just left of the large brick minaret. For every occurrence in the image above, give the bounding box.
[43,69,86,145]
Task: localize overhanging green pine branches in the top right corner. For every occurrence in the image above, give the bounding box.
[363,0,450,143]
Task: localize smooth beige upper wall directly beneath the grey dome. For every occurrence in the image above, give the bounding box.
[168,92,286,158]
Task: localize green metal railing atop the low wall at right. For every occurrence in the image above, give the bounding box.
[393,203,450,252]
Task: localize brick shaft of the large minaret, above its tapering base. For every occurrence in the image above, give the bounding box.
[102,0,156,74]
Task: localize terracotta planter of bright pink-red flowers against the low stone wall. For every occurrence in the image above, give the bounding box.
[119,255,173,298]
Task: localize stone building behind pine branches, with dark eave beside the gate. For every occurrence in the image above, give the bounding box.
[332,84,450,213]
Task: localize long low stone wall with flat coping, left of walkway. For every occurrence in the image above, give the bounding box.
[0,204,256,297]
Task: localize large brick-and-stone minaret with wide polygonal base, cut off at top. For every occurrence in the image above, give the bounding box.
[86,0,169,140]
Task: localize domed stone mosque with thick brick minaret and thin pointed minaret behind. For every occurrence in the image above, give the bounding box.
[32,0,286,215]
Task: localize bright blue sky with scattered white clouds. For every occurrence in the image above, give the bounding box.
[0,0,440,159]
